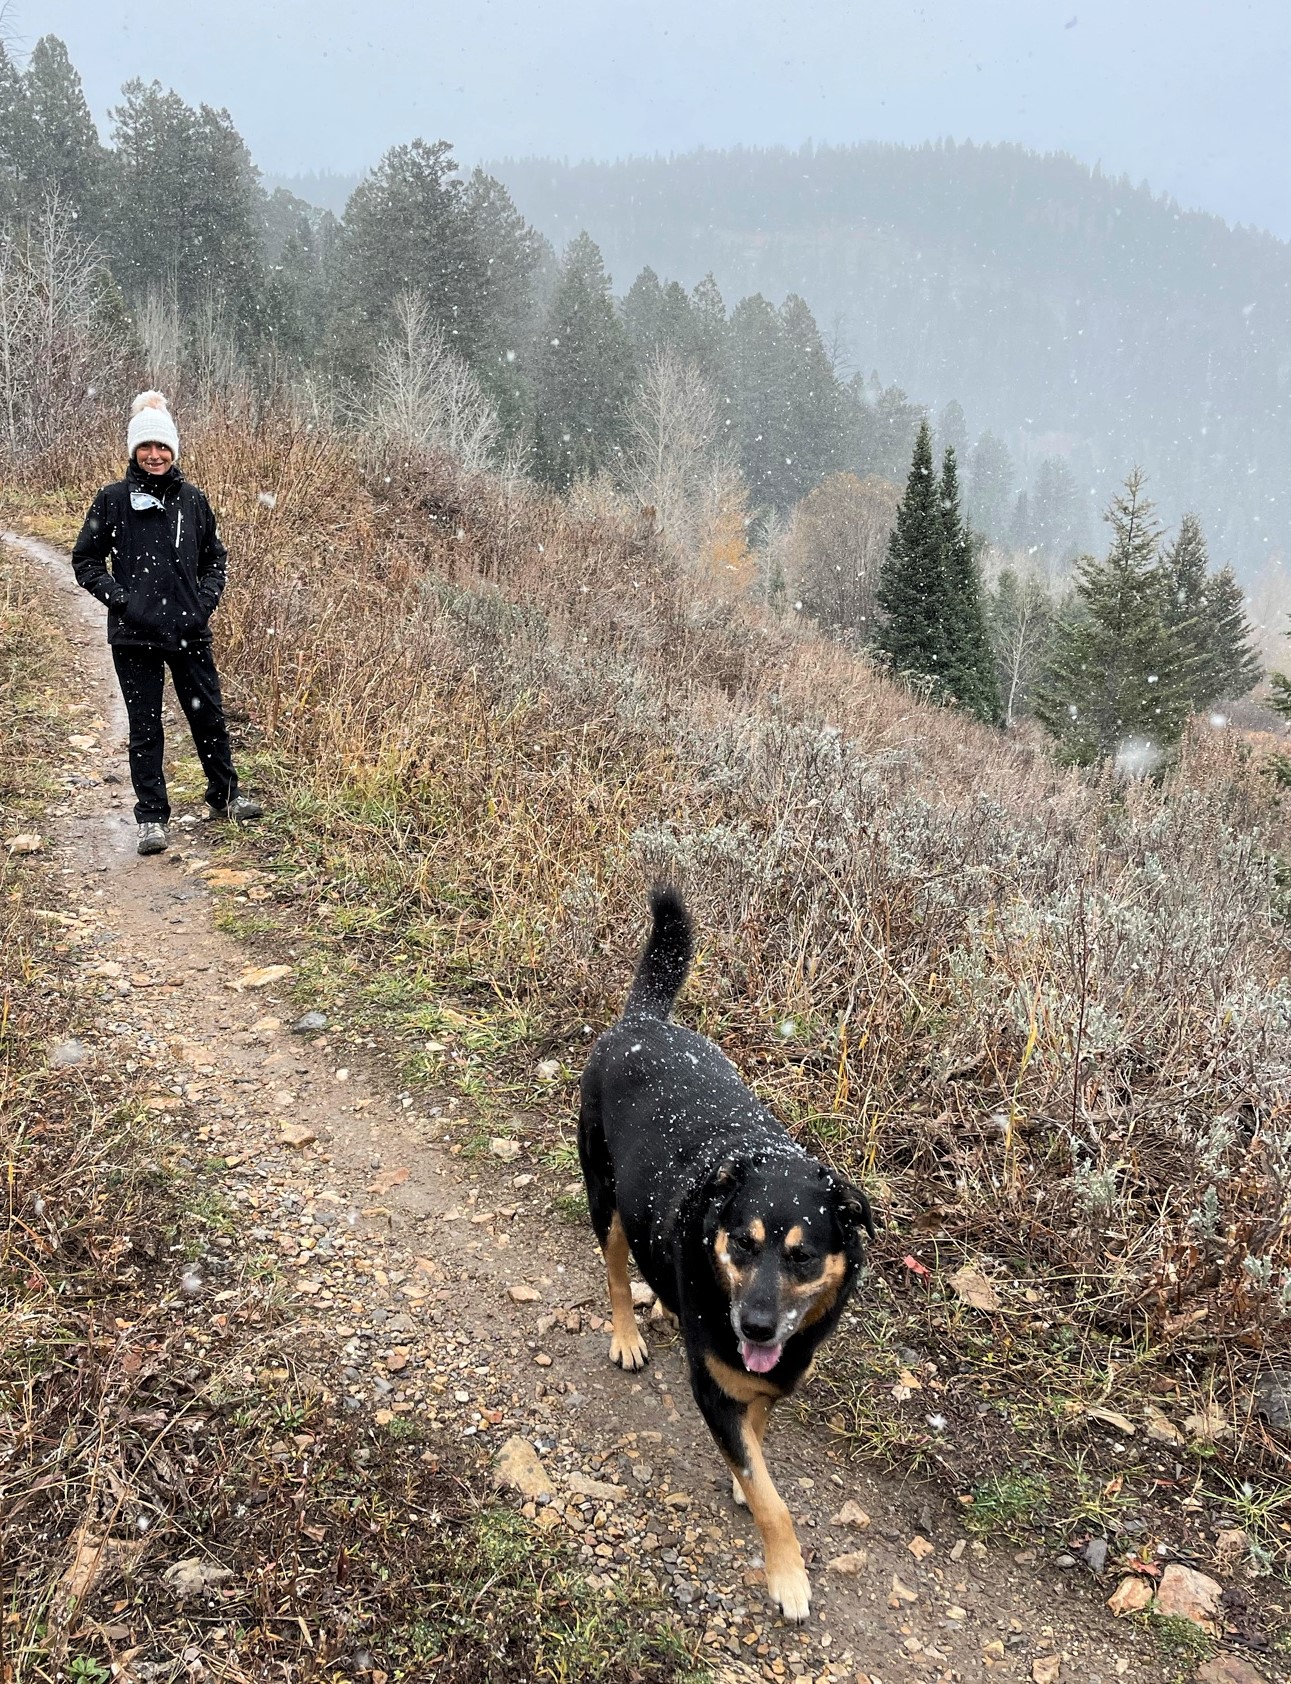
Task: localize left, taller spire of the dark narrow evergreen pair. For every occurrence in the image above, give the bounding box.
[875,421,949,689]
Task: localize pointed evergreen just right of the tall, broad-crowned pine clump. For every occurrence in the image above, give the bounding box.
[534,234,633,490]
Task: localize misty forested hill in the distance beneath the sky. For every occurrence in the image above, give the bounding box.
[493,143,1291,578]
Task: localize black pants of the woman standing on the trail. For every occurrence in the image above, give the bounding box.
[113,643,237,825]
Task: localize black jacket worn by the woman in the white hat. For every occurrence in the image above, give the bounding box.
[72,461,226,650]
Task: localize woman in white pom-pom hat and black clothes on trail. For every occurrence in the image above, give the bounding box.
[72,392,264,854]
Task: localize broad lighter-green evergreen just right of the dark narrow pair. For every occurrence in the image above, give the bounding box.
[1035,468,1188,766]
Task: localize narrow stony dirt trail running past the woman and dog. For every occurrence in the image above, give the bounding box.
[8,536,1211,1684]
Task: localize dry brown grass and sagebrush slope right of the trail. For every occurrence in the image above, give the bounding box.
[15,404,1291,1576]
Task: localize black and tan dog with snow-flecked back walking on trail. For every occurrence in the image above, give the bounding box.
[579,887,874,1620]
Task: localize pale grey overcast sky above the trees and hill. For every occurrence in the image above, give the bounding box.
[20,0,1291,237]
